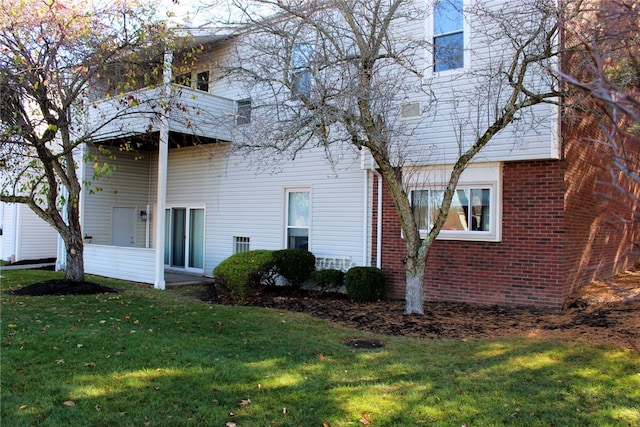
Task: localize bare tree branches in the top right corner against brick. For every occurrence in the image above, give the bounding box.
[561,0,640,229]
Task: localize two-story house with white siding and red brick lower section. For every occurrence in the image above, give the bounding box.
[76,0,633,307]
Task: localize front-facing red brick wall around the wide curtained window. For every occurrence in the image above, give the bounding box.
[374,161,564,306]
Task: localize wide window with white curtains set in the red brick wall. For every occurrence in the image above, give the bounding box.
[411,187,495,238]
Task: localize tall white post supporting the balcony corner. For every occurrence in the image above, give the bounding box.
[153,51,173,289]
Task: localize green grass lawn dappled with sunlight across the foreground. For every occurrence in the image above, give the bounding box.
[0,270,640,427]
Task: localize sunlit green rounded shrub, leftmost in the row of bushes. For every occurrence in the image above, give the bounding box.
[213,249,275,302]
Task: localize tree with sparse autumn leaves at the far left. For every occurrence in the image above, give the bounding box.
[0,0,174,282]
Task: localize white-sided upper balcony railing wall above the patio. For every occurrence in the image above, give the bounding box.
[86,84,235,146]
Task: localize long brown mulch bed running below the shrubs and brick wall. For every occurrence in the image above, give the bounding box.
[199,277,640,352]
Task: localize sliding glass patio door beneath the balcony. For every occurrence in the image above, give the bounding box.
[164,207,204,272]
